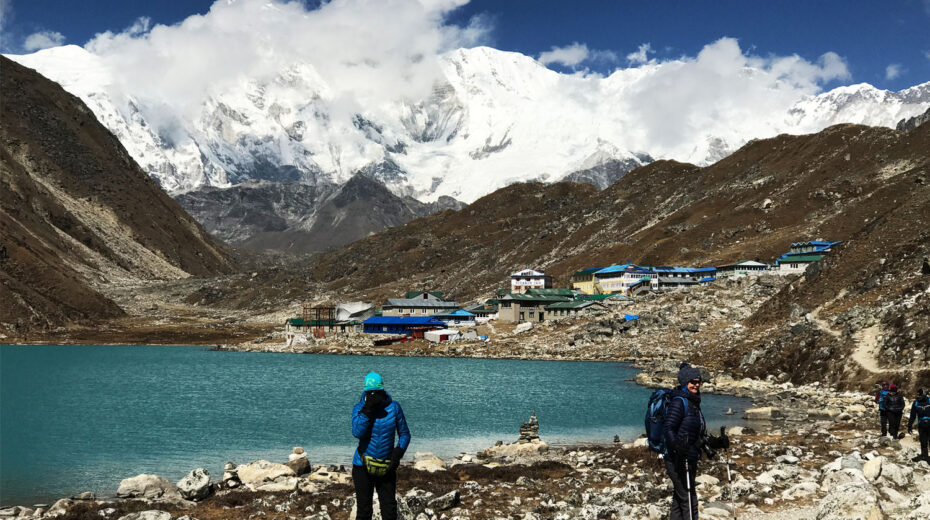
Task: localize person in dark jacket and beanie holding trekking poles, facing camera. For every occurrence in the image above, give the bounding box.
[662,363,730,520]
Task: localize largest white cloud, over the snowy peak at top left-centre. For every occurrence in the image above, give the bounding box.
[85,0,487,121]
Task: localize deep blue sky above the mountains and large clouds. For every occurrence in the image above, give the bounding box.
[0,0,930,90]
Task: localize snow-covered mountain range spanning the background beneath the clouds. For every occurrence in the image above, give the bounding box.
[10,46,930,202]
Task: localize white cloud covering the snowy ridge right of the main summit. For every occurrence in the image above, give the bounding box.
[608,38,850,156]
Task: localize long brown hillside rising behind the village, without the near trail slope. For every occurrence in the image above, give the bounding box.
[207,121,930,320]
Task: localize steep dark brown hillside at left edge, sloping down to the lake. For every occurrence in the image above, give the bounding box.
[0,58,233,334]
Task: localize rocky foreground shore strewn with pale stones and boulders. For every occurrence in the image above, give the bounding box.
[7,371,930,520]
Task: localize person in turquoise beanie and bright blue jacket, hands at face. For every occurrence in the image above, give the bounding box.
[352,372,410,520]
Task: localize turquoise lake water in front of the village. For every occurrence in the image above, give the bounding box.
[0,346,750,504]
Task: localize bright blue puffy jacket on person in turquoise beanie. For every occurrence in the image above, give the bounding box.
[352,392,410,466]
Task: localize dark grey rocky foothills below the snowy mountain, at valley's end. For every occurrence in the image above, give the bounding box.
[176,174,465,254]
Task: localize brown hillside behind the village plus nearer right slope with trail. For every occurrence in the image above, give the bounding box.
[193,119,930,389]
